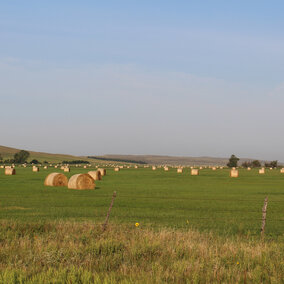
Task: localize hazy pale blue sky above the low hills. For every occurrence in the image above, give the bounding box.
[0,0,284,162]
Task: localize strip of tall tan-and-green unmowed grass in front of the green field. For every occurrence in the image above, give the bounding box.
[0,221,284,283]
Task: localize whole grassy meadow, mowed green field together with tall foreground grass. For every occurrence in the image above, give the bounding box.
[0,167,284,283]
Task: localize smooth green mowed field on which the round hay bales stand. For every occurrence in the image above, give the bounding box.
[0,167,284,239]
